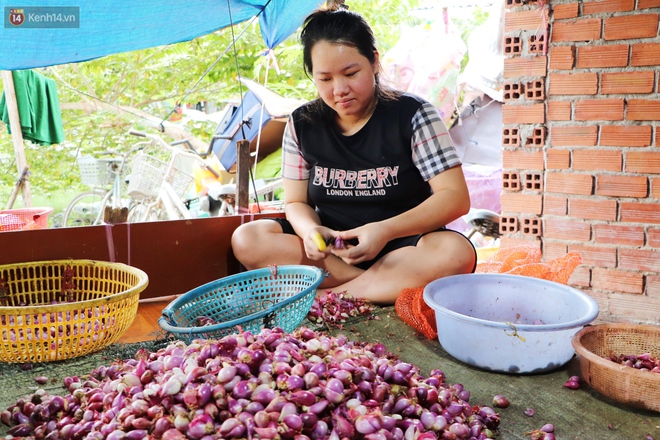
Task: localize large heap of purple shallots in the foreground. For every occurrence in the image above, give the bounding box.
[0,327,500,440]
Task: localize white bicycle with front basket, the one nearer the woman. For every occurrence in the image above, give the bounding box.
[128,130,206,223]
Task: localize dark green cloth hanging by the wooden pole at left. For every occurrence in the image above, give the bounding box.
[0,70,64,145]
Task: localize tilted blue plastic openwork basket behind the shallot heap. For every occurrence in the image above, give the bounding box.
[158,265,325,343]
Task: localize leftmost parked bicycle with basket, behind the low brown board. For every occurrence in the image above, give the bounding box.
[62,147,142,227]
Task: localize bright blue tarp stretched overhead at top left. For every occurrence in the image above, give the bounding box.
[0,0,323,70]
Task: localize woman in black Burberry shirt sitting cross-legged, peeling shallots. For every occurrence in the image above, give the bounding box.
[232,8,476,305]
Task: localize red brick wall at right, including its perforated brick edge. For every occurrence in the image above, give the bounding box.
[501,0,660,324]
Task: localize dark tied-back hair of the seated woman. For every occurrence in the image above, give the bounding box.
[300,7,398,120]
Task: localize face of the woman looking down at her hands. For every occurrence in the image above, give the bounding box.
[311,41,378,120]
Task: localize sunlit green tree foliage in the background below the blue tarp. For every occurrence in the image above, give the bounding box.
[0,0,484,205]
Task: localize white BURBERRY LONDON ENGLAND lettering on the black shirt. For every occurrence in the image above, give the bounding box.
[312,166,399,196]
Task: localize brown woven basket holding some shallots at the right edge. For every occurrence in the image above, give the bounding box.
[572,324,660,411]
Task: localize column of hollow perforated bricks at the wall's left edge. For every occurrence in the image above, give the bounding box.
[500,0,550,248]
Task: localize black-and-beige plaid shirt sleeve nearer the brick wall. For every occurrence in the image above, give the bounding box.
[412,102,461,181]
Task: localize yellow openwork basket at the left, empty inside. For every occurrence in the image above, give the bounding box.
[0,260,148,362]
